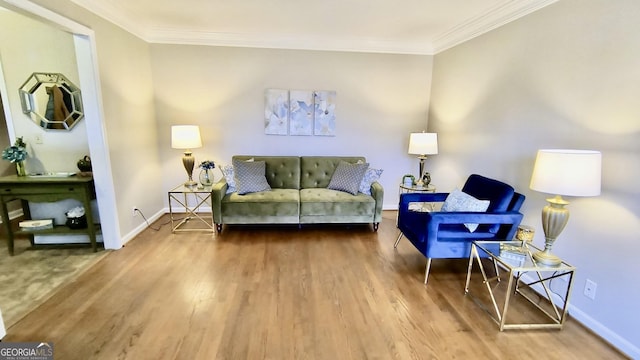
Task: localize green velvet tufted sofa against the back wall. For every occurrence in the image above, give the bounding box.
[212,155,384,232]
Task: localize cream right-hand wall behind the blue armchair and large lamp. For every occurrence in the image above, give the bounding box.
[429,0,640,358]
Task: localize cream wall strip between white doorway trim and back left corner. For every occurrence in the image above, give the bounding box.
[25,0,166,241]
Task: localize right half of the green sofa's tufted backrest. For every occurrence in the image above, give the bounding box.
[300,156,366,189]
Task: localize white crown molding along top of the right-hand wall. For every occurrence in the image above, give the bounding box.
[432,0,558,54]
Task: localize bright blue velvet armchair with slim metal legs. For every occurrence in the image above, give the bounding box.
[394,174,525,284]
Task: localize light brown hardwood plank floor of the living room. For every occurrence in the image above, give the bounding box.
[5,212,624,359]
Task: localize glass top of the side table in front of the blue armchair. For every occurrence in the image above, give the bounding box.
[473,241,575,271]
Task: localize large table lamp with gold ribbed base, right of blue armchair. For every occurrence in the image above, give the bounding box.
[529,149,602,265]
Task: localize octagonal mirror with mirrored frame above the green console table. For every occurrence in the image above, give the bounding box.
[20,73,84,130]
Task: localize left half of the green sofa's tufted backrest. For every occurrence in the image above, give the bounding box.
[233,155,300,189]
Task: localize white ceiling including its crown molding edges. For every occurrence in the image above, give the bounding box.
[71,0,557,55]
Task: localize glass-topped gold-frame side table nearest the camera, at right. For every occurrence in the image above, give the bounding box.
[464,241,576,331]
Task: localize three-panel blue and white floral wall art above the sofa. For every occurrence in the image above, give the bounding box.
[264,89,336,136]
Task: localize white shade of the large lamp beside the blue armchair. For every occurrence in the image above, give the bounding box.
[529,149,602,196]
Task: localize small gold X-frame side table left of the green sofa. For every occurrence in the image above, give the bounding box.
[168,185,215,234]
